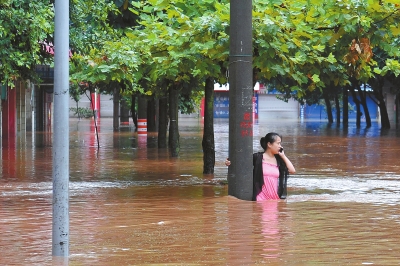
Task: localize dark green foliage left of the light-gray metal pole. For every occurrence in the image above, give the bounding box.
[0,0,54,86]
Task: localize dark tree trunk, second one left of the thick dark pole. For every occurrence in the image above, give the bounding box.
[168,87,179,157]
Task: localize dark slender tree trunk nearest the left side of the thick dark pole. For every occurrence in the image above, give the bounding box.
[201,78,215,174]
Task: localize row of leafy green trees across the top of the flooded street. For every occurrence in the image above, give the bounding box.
[0,0,400,173]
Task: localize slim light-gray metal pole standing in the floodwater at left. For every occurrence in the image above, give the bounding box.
[52,0,69,257]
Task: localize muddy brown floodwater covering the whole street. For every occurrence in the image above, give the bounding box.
[0,119,400,265]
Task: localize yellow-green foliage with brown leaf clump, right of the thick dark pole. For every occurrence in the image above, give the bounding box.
[253,0,400,106]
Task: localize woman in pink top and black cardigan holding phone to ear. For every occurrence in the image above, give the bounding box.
[225,132,296,201]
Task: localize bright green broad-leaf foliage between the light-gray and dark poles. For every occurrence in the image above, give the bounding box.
[71,0,229,112]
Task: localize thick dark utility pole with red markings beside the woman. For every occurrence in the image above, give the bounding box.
[228,0,253,200]
